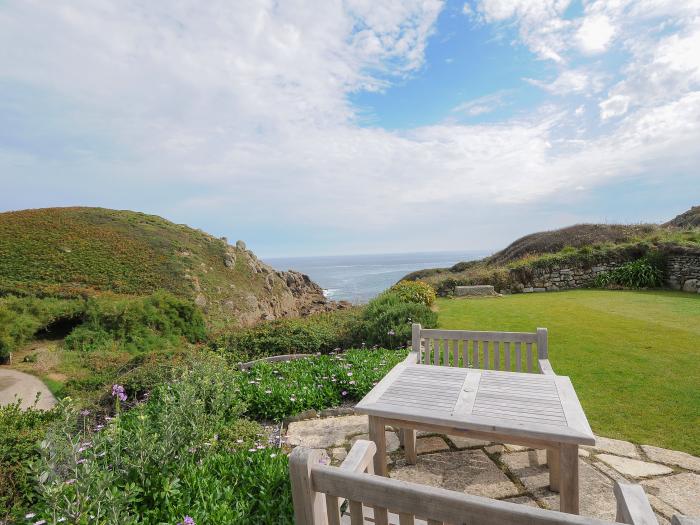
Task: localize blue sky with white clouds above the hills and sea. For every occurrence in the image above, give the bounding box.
[0,0,700,257]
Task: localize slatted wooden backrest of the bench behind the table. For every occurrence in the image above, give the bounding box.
[412,323,548,373]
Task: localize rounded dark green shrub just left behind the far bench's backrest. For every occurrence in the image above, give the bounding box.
[356,292,437,348]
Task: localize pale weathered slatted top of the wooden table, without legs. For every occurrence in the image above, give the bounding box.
[355,364,595,447]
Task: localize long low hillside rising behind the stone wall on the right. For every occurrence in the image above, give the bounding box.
[404,206,700,295]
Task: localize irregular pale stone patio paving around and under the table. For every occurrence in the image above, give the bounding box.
[285,415,700,525]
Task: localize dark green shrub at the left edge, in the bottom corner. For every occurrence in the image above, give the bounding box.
[0,401,58,523]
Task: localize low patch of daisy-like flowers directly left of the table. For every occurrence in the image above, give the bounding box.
[235,349,406,419]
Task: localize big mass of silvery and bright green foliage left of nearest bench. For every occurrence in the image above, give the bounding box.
[31,357,291,525]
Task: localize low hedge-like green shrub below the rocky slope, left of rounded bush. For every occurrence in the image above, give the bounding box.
[214,309,358,361]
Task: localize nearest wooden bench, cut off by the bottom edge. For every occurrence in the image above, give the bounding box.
[289,440,668,525]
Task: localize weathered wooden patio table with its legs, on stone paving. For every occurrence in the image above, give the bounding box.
[355,363,595,514]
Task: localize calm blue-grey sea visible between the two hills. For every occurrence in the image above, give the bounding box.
[265,250,490,303]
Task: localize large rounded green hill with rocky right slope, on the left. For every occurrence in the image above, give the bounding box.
[0,208,329,326]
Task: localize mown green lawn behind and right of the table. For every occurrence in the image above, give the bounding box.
[438,290,700,455]
